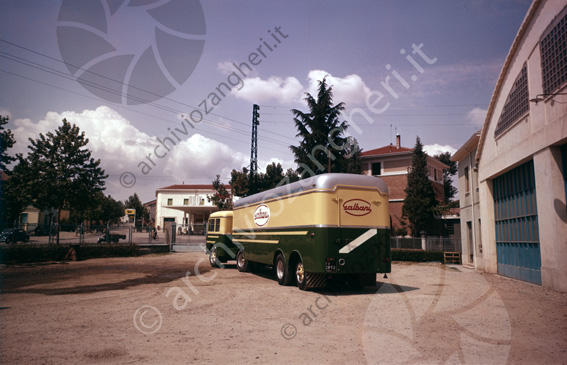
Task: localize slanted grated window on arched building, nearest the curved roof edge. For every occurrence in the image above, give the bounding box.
[494,65,530,137]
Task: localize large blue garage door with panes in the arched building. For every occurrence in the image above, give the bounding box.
[493,161,541,285]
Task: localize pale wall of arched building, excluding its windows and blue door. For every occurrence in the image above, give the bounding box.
[477,1,567,291]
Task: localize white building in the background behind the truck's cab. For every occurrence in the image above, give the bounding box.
[155,184,230,234]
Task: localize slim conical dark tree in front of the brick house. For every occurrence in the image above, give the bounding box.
[402,137,439,237]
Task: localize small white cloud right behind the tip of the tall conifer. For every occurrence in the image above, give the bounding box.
[307,70,372,107]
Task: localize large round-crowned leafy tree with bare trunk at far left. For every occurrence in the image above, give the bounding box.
[26,119,108,243]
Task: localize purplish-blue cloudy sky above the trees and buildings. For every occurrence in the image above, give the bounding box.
[0,0,531,202]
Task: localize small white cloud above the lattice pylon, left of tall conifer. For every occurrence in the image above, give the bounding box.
[232,77,303,104]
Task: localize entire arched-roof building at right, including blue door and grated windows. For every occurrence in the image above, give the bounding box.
[474,0,567,292]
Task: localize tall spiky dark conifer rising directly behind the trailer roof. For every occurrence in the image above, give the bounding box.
[290,78,348,177]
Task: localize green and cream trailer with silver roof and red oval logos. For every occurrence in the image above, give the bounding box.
[207,174,391,290]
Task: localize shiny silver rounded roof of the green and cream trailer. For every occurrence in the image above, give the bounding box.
[234,173,388,208]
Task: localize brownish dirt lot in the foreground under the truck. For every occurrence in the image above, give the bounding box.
[0,252,567,364]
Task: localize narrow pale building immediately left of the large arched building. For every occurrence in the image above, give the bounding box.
[451,132,482,265]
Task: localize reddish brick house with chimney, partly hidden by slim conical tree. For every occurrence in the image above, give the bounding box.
[360,135,449,233]
